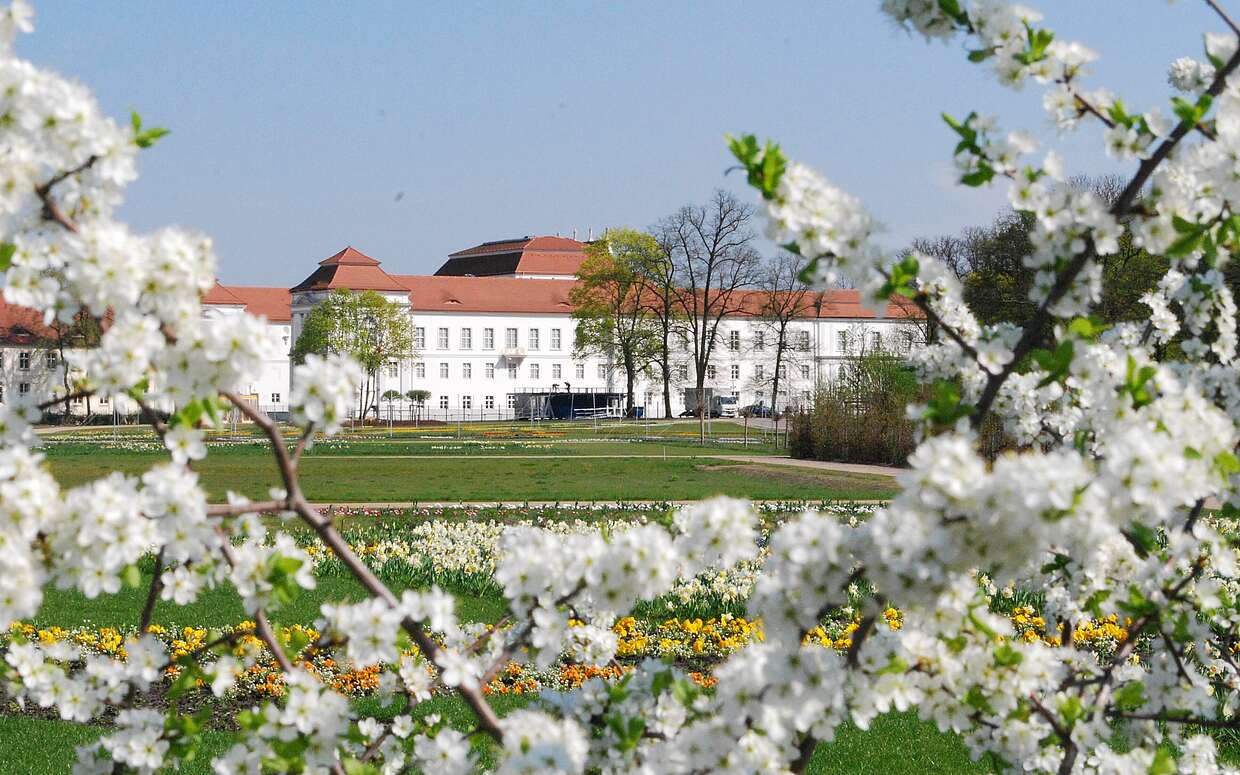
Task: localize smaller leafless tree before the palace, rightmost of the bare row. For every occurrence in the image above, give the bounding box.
[756,253,816,438]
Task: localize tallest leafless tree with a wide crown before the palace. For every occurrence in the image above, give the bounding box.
[657,191,760,439]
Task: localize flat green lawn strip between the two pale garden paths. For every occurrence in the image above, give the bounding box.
[41,450,895,503]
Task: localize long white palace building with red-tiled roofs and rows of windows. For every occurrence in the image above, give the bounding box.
[0,237,923,420]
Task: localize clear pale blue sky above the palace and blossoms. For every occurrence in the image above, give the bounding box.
[19,0,1220,285]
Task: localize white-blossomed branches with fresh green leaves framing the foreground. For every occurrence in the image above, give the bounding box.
[0,0,1240,775]
